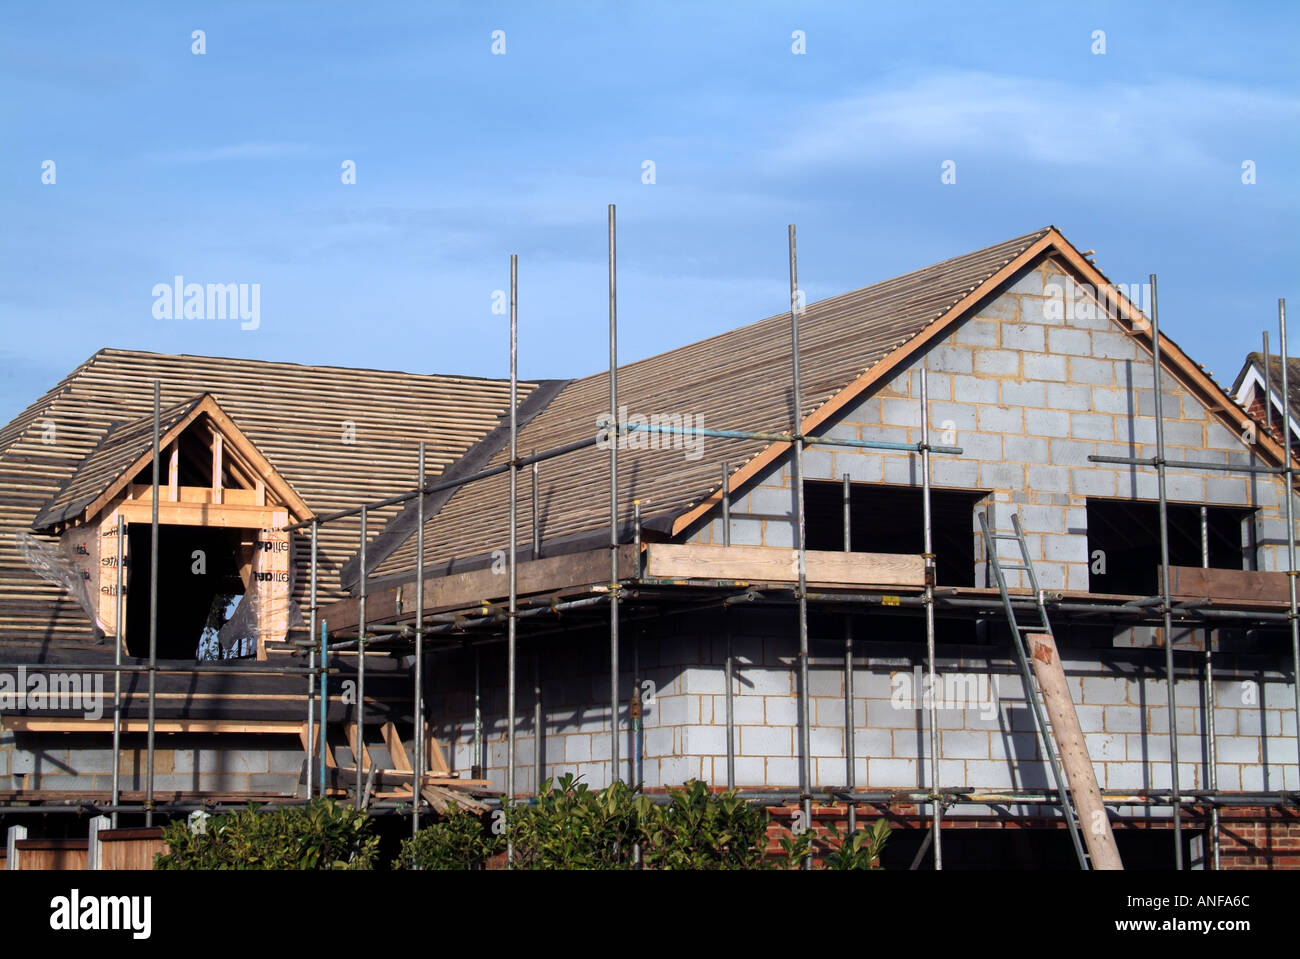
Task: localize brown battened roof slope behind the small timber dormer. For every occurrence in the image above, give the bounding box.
[0,350,536,643]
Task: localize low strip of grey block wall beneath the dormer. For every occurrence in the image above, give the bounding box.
[0,732,306,797]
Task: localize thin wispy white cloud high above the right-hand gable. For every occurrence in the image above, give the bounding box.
[767,71,1300,172]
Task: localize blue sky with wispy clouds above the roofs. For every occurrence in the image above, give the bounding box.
[0,0,1300,422]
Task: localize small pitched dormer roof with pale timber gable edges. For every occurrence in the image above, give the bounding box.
[33,392,313,530]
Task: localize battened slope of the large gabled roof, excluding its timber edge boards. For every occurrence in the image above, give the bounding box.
[374,227,1052,578]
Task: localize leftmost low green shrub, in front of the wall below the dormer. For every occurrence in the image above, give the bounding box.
[153,799,380,869]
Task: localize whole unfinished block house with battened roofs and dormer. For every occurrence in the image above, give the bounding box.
[0,220,1300,868]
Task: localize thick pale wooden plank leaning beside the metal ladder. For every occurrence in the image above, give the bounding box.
[1027,633,1125,869]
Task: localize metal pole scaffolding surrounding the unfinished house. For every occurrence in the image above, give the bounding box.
[0,213,1300,869]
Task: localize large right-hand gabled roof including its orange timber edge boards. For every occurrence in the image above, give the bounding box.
[372,227,1300,582]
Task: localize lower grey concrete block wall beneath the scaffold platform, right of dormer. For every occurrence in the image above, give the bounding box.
[432,612,1300,800]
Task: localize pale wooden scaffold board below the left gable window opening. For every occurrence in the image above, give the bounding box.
[646,543,926,589]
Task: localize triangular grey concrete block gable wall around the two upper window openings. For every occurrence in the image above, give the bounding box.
[692,261,1300,591]
